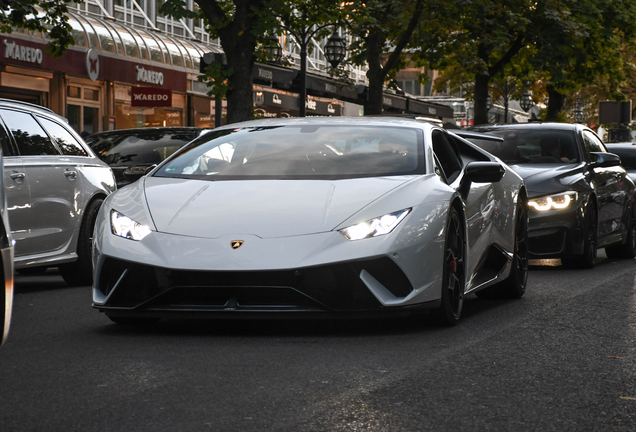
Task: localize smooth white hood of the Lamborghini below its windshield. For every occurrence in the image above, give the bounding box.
[145,177,409,238]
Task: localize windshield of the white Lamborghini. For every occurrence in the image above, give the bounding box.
[154,125,425,180]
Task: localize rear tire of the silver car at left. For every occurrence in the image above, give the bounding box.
[59,198,104,286]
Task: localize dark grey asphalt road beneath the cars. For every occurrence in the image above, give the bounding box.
[0,253,636,432]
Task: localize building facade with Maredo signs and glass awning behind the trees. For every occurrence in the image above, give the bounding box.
[0,0,452,133]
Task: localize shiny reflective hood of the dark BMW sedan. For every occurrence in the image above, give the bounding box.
[510,163,586,196]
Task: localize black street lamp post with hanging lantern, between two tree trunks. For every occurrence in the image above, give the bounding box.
[281,23,347,117]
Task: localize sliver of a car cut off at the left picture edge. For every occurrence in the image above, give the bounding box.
[0,145,13,346]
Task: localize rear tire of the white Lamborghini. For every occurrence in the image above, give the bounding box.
[476,200,528,299]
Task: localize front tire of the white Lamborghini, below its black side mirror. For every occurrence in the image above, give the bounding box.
[433,207,466,326]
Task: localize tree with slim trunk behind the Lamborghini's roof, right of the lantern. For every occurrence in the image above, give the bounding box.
[344,0,425,115]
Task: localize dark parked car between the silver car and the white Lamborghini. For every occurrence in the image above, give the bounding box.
[84,127,209,188]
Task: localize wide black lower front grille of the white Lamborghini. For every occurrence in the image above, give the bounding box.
[99,258,412,311]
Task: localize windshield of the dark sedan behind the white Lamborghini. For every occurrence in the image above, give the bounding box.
[468,128,581,165]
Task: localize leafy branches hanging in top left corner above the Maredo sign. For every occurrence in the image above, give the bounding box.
[0,0,74,57]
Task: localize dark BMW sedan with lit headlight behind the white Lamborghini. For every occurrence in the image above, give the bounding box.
[459,123,636,268]
